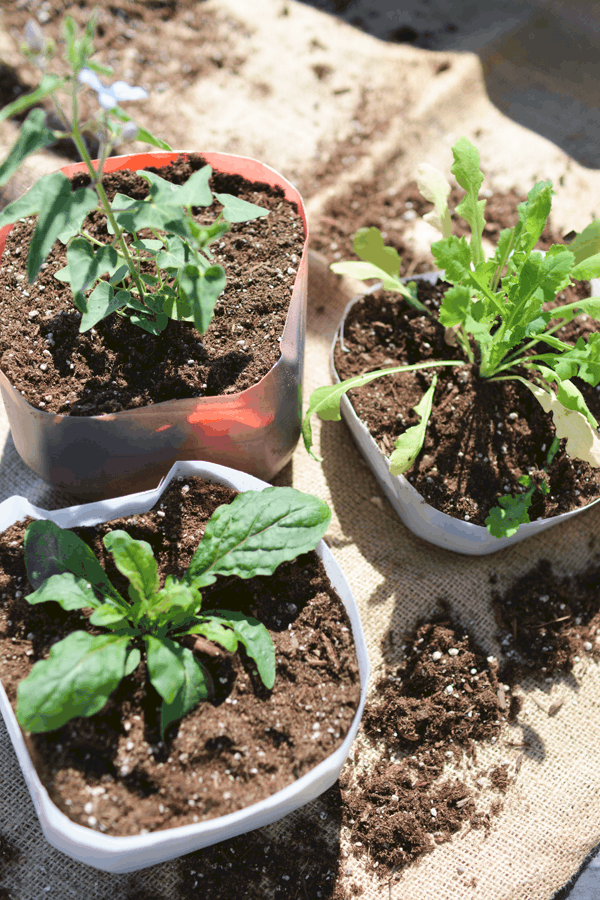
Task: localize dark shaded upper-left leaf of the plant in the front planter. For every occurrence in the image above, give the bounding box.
[24,519,127,608]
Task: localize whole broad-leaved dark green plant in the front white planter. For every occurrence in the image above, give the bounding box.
[17,487,331,735]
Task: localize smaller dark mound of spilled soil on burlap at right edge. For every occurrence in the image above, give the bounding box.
[493,559,600,678]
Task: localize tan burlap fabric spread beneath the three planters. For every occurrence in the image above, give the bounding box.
[0,0,600,900]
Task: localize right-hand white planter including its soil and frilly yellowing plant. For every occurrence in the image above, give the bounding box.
[303,138,600,554]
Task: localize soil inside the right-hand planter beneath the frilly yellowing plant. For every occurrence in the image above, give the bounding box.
[335,282,600,525]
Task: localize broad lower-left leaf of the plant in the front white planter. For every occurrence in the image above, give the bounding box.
[17,631,131,733]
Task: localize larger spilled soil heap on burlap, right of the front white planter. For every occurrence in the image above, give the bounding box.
[342,611,510,876]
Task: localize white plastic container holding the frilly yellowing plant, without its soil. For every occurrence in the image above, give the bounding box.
[331,272,600,556]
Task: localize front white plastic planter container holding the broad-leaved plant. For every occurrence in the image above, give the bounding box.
[0,462,369,873]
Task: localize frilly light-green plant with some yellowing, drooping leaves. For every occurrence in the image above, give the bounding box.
[303,138,600,537]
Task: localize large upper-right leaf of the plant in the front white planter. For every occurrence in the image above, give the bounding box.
[186,487,331,588]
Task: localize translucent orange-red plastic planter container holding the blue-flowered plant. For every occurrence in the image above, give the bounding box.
[0,152,308,498]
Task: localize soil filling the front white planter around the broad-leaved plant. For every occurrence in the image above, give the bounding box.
[0,479,360,834]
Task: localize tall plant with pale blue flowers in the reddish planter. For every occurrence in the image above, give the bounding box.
[0,17,268,334]
